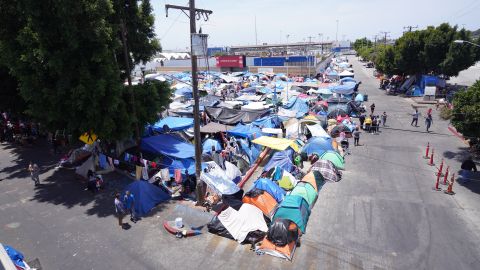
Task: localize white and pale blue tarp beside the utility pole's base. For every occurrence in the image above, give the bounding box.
[200,161,240,195]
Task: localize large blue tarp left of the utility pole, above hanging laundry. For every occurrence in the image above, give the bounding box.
[140,134,195,159]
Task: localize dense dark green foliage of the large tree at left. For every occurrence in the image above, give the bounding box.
[0,0,164,140]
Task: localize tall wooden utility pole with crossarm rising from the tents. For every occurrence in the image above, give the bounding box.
[165,0,213,205]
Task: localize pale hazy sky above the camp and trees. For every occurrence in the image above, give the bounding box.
[151,0,480,51]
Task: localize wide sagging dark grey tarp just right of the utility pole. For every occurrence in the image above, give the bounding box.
[205,107,269,125]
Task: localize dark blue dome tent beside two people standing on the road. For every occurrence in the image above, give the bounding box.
[123,180,170,216]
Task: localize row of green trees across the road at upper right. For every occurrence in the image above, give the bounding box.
[375,23,480,76]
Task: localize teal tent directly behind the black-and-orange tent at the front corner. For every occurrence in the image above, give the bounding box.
[272,195,310,233]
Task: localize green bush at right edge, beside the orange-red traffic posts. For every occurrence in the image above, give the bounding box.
[451,81,480,138]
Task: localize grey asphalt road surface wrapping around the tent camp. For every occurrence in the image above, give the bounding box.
[0,57,480,269]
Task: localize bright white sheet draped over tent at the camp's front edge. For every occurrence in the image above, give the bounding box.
[218,203,268,243]
